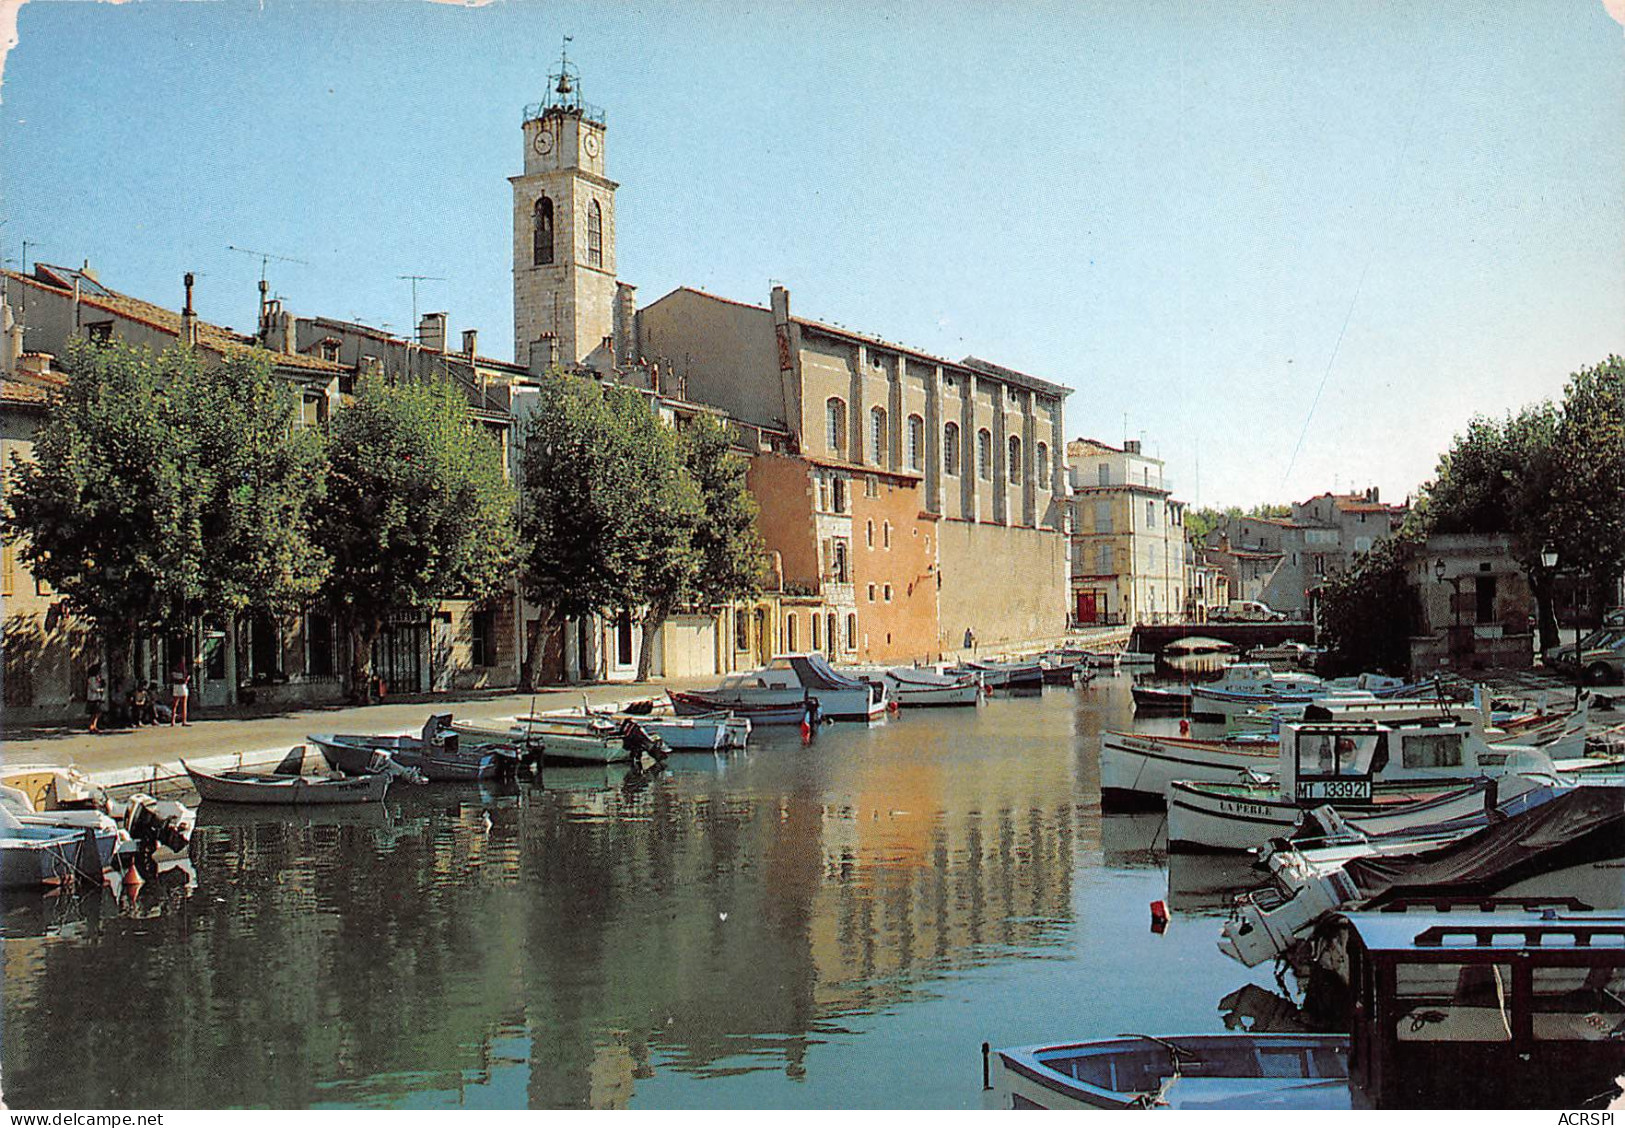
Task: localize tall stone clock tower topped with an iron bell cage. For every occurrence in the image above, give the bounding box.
[509,48,616,369]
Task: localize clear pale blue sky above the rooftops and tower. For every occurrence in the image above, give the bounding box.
[0,0,1625,505]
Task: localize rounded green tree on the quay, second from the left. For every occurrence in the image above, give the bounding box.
[315,377,515,701]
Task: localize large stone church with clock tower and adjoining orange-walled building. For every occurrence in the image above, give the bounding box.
[512,62,1071,662]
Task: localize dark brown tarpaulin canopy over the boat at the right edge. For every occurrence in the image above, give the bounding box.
[1344,787,1625,907]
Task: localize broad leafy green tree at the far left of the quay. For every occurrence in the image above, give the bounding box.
[5,341,325,681]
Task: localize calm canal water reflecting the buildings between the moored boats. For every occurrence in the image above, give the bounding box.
[0,676,1292,1108]
